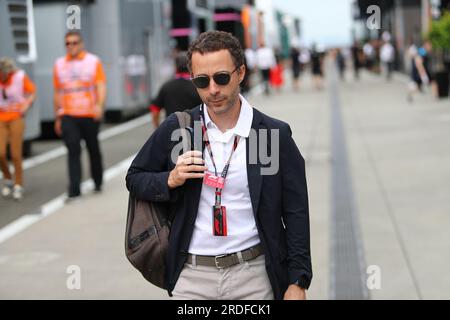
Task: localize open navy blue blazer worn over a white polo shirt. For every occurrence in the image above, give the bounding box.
[126,106,312,299]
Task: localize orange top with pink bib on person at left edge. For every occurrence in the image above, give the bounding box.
[0,70,25,121]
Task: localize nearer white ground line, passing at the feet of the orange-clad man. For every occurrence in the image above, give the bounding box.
[0,155,136,243]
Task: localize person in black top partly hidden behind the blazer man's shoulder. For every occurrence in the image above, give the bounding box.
[149,51,202,128]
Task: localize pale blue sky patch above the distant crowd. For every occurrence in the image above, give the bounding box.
[272,0,353,46]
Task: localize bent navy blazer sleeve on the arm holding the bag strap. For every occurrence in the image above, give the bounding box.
[126,114,179,202]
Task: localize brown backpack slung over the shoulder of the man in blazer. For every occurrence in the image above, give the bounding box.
[125,112,191,289]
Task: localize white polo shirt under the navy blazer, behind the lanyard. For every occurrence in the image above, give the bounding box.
[189,95,260,256]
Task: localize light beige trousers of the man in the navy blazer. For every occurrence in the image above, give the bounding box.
[172,255,273,300]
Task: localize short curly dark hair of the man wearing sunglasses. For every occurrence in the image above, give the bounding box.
[187,30,244,73]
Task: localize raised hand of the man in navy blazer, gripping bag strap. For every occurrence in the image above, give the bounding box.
[167,151,208,189]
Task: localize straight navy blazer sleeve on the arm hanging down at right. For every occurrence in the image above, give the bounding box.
[280,125,312,289]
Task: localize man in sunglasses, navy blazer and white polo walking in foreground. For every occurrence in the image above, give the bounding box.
[126,31,312,299]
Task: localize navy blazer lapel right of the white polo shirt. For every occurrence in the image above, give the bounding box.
[246,108,263,217]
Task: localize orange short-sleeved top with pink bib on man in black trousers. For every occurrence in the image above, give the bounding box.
[54,52,105,117]
